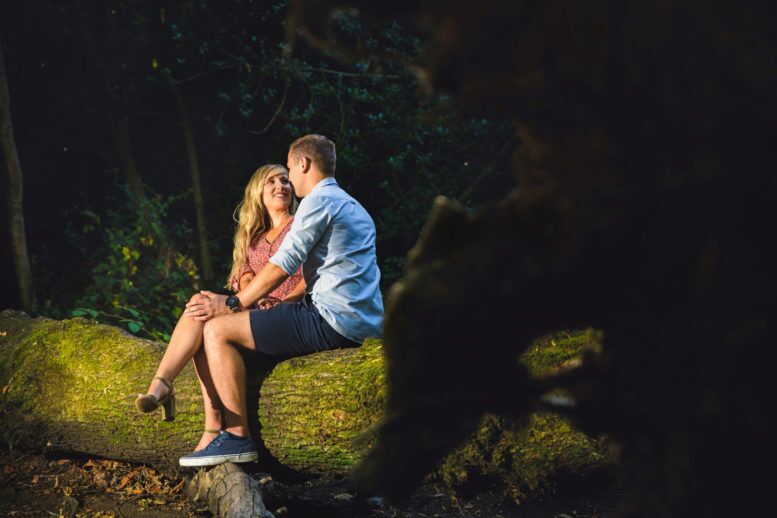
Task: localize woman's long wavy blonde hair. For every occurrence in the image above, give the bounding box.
[225,164,297,289]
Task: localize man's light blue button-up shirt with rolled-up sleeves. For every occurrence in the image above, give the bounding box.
[270,178,383,343]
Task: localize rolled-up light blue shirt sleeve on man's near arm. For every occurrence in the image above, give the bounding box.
[270,198,331,275]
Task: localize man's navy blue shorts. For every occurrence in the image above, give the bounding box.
[248,297,361,358]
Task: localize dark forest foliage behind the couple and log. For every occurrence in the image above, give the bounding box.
[0,0,516,339]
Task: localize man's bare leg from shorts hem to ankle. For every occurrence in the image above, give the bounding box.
[203,311,255,437]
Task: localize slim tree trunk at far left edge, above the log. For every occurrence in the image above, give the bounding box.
[0,39,33,312]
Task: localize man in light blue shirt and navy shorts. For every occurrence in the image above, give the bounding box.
[180,135,383,466]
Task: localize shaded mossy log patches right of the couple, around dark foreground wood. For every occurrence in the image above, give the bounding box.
[439,329,614,503]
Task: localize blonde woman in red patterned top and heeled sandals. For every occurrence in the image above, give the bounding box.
[135,164,305,451]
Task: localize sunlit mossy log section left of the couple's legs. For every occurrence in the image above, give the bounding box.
[0,311,218,470]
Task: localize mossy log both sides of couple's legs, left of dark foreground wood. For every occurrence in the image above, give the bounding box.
[0,311,385,473]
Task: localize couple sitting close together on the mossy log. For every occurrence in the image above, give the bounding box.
[135,135,383,466]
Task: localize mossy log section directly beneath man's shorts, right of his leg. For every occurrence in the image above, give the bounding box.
[259,340,386,474]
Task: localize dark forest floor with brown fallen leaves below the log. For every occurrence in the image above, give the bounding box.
[0,451,613,518]
